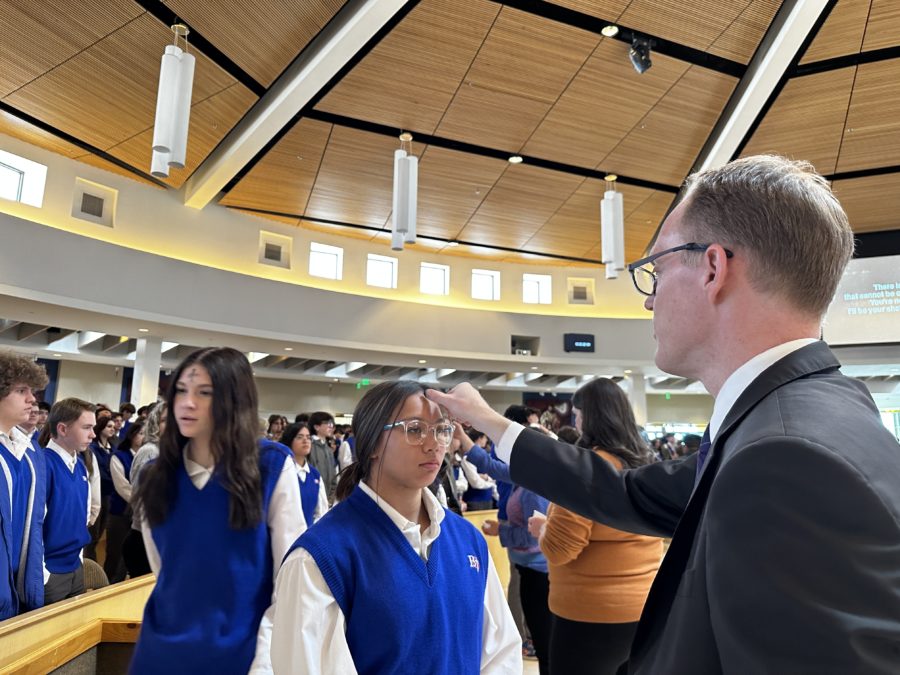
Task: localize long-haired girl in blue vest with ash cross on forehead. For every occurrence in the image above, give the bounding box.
[131,348,306,674]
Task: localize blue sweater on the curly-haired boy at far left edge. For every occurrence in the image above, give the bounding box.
[0,445,47,620]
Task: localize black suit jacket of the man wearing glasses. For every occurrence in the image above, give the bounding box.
[510,342,900,675]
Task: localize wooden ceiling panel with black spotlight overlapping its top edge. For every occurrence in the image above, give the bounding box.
[524,40,690,168]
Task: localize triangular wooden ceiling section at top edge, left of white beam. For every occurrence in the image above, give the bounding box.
[164,0,345,86]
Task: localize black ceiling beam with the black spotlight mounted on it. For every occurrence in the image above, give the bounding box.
[491,0,747,78]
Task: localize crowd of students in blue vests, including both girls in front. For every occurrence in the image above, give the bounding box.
[0,348,658,673]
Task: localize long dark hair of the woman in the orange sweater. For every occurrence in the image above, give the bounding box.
[572,377,650,469]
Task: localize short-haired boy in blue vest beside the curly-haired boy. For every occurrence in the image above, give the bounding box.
[44,398,97,605]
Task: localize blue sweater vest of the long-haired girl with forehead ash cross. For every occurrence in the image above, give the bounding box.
[130,440,290,675]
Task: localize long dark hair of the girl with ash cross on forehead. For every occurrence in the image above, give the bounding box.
[135,347,262,530]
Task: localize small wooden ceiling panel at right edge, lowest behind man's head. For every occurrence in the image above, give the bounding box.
[833,173,900,232]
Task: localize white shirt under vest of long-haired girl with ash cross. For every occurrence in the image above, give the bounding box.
[141,448,306,675]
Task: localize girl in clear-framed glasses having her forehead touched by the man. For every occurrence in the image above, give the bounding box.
[272,381,522,675]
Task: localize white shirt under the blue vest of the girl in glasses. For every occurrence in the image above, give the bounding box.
[266,483,522,675]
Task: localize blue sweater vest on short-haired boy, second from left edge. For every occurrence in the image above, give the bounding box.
[44,450,91,574]
